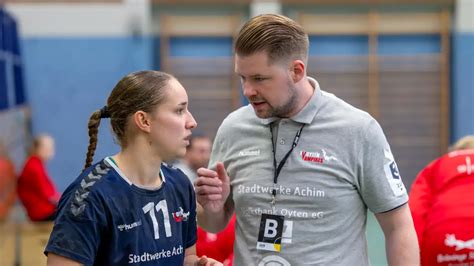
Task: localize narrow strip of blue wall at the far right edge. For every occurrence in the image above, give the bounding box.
[451,33,474,141]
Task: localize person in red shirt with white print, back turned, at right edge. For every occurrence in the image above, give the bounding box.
[409,136,474,266]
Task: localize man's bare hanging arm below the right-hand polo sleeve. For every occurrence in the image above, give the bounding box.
[375,204,420,266]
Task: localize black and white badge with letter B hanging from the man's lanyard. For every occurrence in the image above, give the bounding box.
[257,213,285,252]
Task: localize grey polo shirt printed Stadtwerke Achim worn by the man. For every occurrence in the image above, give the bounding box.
[209,78,408,265]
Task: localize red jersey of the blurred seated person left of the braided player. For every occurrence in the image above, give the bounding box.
[17,155,60,221]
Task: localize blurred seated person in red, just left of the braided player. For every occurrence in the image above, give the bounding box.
[17,135,60,221]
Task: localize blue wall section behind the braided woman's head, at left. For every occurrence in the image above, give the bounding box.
[22,37,152,191]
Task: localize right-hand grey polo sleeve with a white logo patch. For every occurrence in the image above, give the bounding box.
[358,118,408,213]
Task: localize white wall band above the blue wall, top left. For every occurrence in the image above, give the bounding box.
[6,0,150,37]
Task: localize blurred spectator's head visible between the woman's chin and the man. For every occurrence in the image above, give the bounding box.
[174,134,212,182]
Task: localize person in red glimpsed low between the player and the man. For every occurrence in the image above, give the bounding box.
[196,214,235,266]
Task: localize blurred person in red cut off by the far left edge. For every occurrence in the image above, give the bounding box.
[0,143,16,221]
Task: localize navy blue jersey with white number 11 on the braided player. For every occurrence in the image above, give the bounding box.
[45,158,196,265]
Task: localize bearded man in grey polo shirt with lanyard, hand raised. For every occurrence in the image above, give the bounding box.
[195,15,419,265]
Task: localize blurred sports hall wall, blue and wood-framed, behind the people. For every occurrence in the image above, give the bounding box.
[0,0,474,265]
